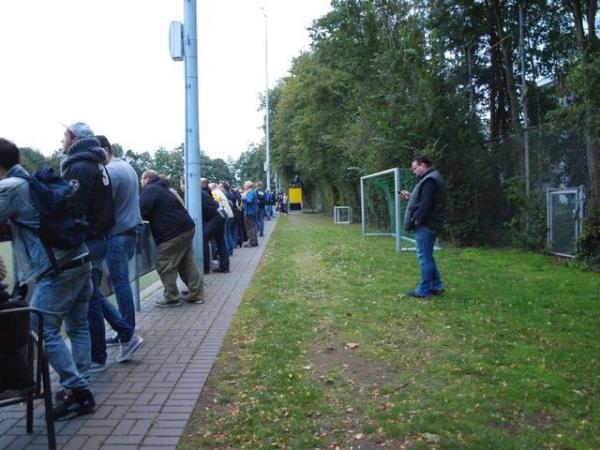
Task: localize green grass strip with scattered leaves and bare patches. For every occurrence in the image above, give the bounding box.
[180,215,600,450]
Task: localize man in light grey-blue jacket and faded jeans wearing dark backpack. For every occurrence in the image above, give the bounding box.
[0,138,95,420]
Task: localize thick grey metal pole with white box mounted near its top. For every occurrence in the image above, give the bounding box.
[170,0,204,270]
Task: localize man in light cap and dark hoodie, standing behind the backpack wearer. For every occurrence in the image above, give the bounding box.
[60,122,133,373]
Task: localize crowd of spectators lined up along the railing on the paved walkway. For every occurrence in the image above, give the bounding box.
[0,122,276,420]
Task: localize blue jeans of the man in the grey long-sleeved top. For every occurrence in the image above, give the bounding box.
[103,236,137,332]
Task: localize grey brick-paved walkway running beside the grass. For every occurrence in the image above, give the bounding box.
[0,217,276,450]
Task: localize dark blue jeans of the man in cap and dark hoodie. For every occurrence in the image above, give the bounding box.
[85,239,133,364]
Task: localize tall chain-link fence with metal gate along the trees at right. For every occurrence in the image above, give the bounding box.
[460,128,600,256]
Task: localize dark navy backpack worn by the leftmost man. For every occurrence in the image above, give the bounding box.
[15,168,90,269]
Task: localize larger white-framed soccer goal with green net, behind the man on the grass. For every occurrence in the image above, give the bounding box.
[360,167,416,252]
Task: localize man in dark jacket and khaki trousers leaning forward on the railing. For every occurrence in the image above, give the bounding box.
[140,170,204,308]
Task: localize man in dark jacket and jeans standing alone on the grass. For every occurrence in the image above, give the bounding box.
[400,156,446,298]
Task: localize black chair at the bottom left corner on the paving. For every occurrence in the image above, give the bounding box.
[0,302,56,450]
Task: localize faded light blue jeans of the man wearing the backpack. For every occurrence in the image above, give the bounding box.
[31,263,92,389]
